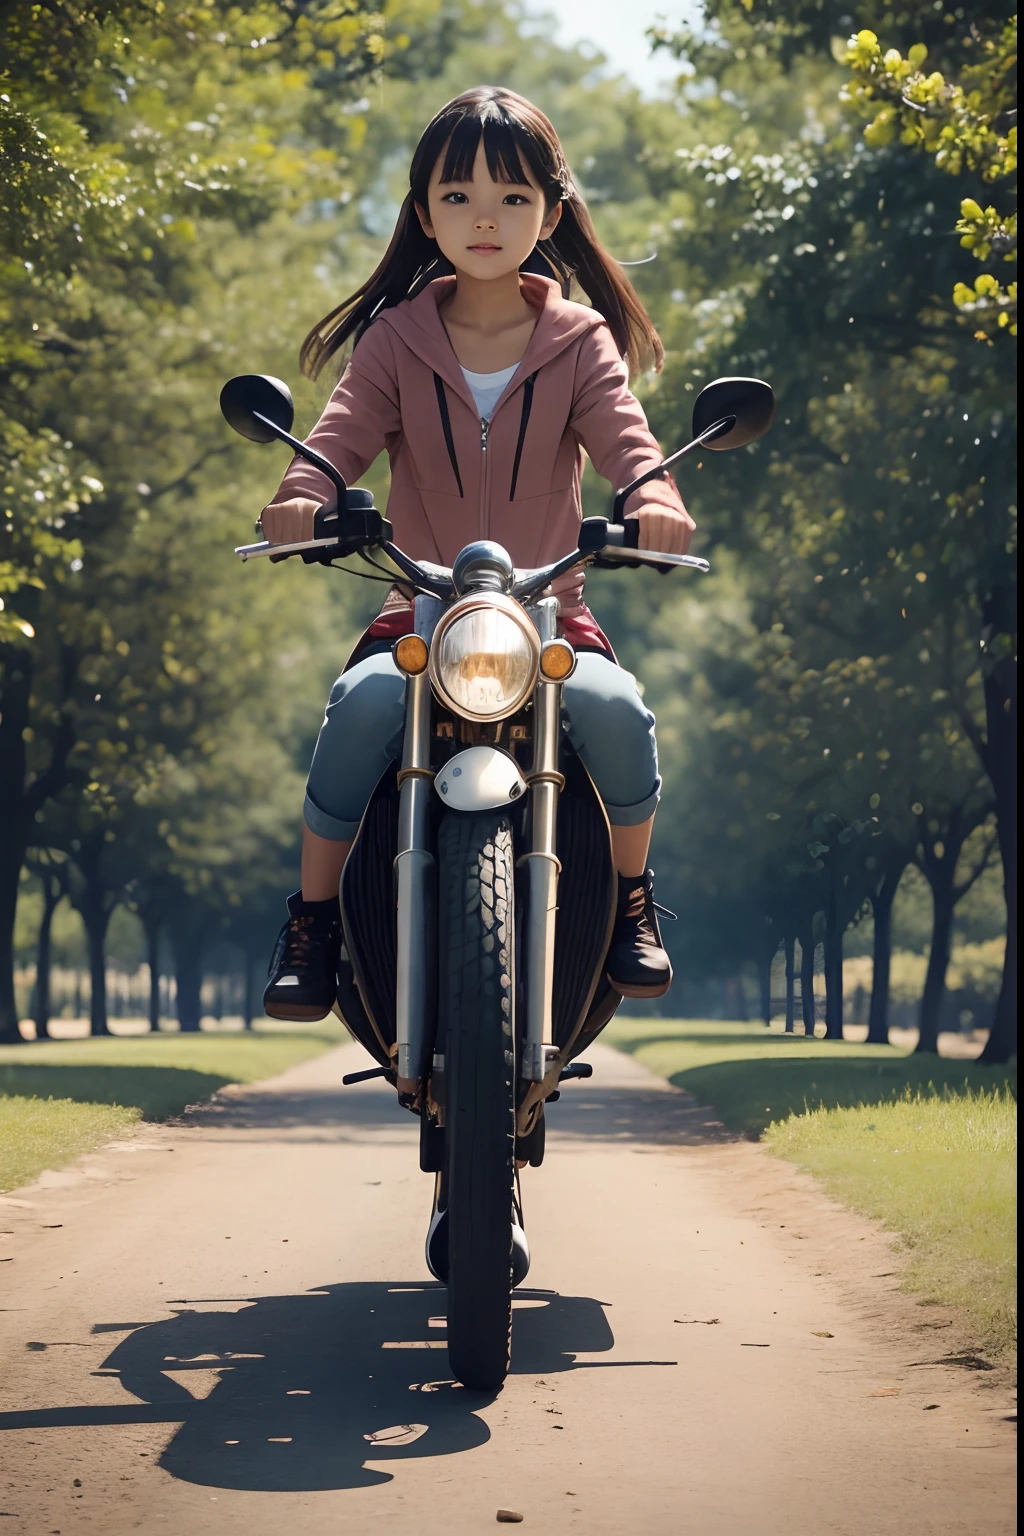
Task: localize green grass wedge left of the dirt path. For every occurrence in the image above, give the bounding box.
[0,1020,347,1190]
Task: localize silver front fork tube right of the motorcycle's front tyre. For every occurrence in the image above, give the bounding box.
[519,598,565,1083]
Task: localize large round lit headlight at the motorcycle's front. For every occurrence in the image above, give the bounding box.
[430,598,540,720]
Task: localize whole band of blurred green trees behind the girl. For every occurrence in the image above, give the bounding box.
[0,0,1016,1058]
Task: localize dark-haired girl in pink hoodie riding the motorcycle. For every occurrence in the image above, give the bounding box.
[261,86,694,1018]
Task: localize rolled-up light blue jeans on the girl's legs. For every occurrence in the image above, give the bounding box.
[304,651,662,843]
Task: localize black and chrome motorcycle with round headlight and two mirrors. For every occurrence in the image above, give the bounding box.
[221,365,774,1392]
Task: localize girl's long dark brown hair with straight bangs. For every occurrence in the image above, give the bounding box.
[299,86,665,378]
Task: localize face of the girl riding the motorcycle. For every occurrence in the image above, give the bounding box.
[416,135,562,281]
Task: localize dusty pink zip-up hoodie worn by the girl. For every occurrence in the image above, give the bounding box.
[273,273,682,616]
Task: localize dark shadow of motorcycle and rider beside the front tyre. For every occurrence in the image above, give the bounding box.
[0,1283,632,1491]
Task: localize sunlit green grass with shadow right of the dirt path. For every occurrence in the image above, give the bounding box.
[605,1018,1016,1355]
